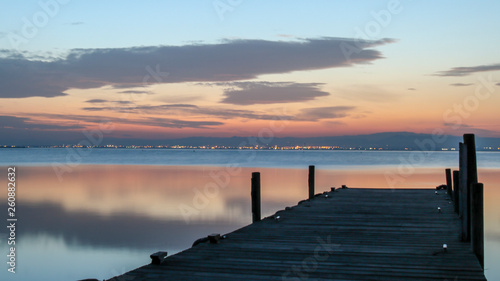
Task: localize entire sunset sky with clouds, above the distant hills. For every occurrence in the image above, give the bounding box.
[0,0,500,145]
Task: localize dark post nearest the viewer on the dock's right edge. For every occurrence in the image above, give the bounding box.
[471,183,484,270]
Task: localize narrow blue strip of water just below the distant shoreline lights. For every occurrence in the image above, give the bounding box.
[0,148,500,169]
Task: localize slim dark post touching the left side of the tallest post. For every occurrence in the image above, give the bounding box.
[458,143,470,242]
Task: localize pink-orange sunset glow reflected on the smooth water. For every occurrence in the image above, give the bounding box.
[2,165,480,220]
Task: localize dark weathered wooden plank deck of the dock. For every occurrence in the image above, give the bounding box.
[110,188,486,281]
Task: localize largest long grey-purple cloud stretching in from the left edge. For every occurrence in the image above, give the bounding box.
[0,38,393,98]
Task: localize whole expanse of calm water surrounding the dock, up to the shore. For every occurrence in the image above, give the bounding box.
[0,149,500,281]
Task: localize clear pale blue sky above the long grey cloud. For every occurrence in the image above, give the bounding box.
[0,0,500,51]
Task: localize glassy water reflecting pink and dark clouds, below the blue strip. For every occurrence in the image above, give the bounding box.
[0,165,500,280]
